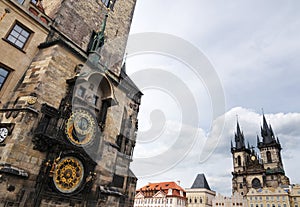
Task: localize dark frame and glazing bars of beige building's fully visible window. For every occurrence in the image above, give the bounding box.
[5,20,33,51]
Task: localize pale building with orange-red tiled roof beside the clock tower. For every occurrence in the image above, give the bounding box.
[134,182,186,207]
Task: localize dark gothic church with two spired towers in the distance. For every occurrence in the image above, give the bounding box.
[231,115,290,196]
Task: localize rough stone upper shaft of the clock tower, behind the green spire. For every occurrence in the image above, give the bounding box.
[44,0,136,76]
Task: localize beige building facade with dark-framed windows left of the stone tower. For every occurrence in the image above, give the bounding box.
[0,0,51,108]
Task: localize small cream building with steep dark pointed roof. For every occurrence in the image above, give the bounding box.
[185,174,216,207]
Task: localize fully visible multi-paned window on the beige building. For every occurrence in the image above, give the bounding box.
[6,22,31,49]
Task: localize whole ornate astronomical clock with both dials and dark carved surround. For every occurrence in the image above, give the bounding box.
[33,77,101,199]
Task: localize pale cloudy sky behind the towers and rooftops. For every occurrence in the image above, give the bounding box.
[123,0,300,195]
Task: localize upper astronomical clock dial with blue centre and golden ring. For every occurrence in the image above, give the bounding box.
[66,110,96,146]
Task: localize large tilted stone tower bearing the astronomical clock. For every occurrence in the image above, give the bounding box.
[0,0,142,207]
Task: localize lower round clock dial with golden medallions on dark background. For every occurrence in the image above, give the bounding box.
[53,157,84,193]
